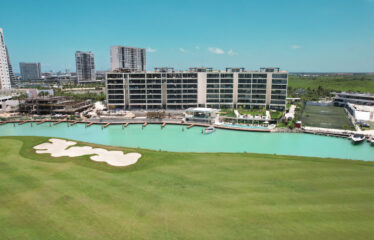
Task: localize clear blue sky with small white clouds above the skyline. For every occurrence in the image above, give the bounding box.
[0,0,374,72]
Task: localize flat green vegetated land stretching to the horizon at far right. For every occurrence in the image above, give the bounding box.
[288,75,374,93]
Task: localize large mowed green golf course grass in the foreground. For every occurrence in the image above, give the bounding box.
[0,137,374,240]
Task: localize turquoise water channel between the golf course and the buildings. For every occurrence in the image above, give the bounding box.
[0,123,374,161]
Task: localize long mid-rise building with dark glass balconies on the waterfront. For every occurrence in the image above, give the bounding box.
[106,68,288,110]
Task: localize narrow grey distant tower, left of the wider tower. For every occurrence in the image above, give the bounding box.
[75,51,96,83]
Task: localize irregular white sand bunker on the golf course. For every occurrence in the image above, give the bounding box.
[34,138,142,167]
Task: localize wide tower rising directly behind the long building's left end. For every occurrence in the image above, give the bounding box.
[110,46,146,71]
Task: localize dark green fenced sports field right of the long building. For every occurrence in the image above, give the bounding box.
[301,105,354,130]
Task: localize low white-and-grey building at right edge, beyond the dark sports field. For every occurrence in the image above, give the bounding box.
[332,92,374,107]
